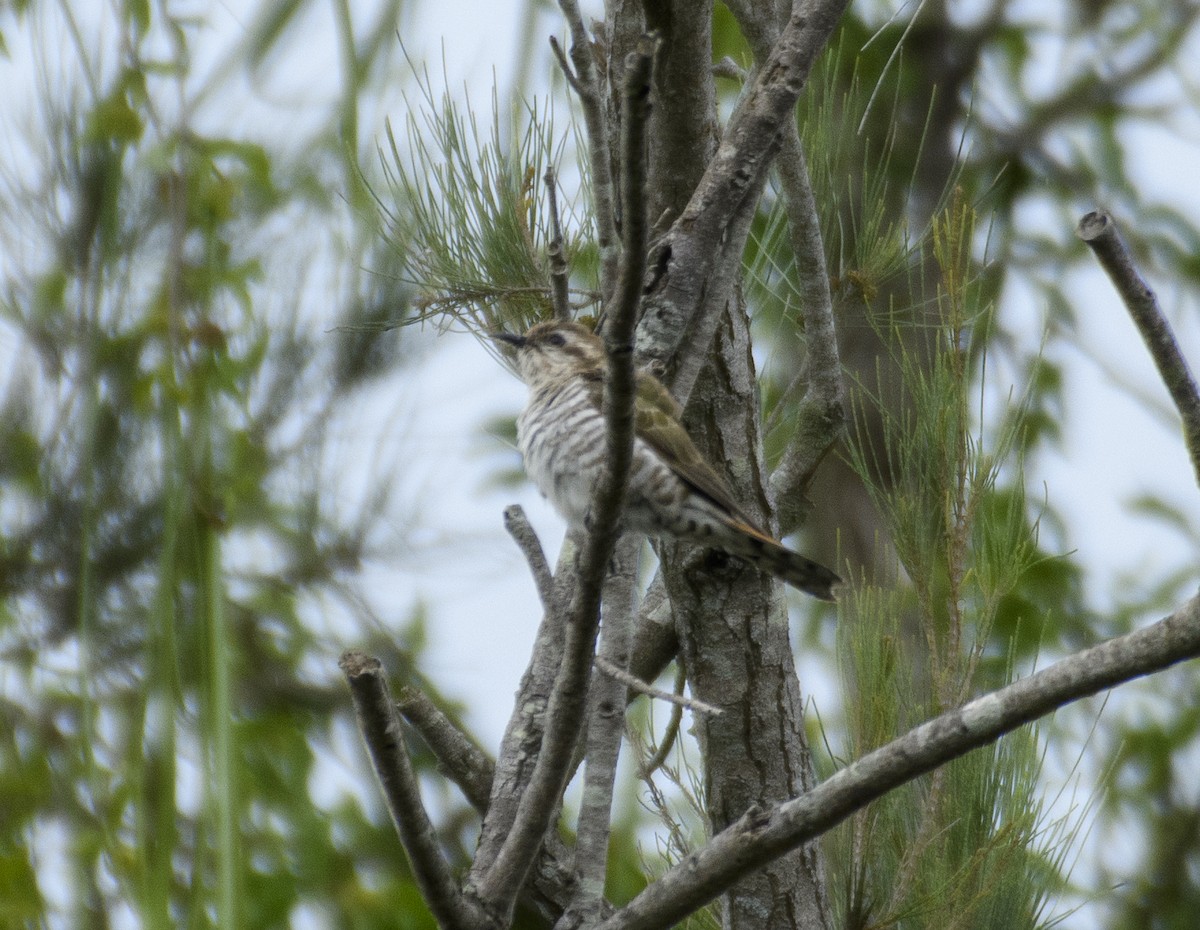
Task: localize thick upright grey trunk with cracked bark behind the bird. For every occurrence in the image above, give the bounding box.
[608,0,828,930]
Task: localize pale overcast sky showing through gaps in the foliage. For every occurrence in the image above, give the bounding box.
[0,0,1200,926]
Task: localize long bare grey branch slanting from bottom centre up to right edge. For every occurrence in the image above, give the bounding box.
[600,598,1200,930]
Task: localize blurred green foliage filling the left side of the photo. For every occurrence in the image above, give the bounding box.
[0,4,466,928]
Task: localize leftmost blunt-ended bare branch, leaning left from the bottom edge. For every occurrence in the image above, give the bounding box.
[338,652,491,930]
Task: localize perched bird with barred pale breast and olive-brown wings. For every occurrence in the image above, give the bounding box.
[492,320,840,600]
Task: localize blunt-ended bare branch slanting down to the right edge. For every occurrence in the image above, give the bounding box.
[1075,211,1200,481]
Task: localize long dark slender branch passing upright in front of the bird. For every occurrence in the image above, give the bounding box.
[476,39,654,914]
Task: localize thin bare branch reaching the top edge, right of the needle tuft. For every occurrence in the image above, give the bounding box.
[553,0,620,301]
